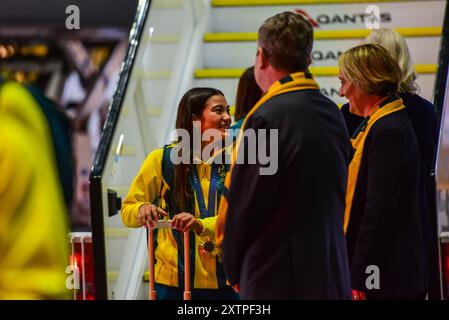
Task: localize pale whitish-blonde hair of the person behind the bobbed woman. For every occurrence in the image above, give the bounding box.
[365,29,419,94]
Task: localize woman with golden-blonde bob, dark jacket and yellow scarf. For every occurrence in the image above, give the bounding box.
[339,44,425,299]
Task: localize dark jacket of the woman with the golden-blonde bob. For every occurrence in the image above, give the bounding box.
[347,111,425,299]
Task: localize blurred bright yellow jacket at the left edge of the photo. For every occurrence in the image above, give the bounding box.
[0,83,70,300]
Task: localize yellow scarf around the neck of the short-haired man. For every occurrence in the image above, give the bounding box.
[215,72,319,245]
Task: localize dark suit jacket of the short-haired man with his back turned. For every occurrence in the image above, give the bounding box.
[223,90,351,299]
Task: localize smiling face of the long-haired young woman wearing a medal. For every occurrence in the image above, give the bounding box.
[200,95,231,138]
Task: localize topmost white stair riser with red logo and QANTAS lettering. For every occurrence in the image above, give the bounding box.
[207,0,446,33]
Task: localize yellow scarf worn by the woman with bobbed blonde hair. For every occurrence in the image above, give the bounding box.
[343,95,405,233]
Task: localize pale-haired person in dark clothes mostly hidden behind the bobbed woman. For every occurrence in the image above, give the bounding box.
[341,29,439,294]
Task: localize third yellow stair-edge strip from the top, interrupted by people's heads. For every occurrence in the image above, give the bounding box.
[195,64,437,78]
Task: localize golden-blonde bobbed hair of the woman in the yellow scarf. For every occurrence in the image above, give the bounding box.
[338,43,401,96]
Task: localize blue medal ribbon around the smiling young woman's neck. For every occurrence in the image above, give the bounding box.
[192,164,218,219]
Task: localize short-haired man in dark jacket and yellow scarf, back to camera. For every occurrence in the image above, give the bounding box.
[217,12,351,299]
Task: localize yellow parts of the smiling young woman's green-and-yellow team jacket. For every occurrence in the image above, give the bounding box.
[121,148,224,289]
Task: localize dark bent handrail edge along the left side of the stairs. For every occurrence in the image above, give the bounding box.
[89,0,151,300]
